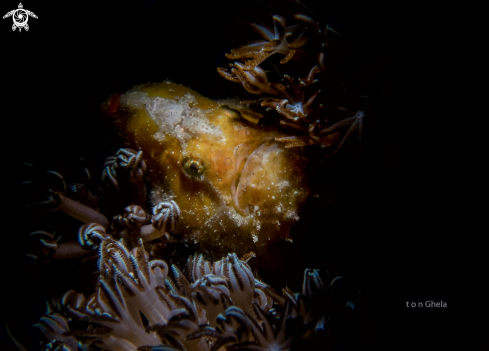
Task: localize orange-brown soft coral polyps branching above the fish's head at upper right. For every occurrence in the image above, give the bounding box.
[218,1,363,152]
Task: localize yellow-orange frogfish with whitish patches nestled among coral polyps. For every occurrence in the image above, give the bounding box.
[103,82,309,253]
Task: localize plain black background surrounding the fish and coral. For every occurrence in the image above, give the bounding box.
[0,0,489,350]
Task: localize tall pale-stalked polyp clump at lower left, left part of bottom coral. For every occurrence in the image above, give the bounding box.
[45,238,177,351]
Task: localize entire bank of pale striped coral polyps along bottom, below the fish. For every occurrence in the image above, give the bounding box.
[34,234,350,351]
